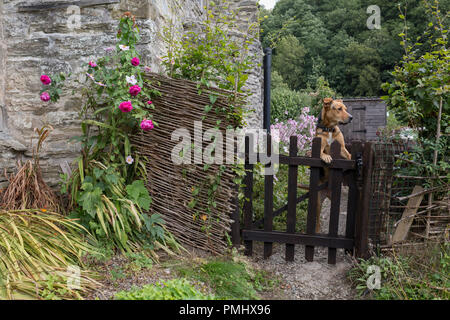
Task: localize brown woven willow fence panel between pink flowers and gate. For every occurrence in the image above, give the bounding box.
[132,73,244,254]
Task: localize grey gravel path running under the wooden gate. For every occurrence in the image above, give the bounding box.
[251,187,355,300]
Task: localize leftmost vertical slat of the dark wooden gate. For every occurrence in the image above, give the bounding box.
[243,136,254,256]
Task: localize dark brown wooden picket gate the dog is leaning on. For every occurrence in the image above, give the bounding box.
[232,136,373,264]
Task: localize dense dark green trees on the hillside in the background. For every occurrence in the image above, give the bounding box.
[261,0,450,97]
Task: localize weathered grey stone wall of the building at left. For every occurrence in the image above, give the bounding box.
[0,0,262,187]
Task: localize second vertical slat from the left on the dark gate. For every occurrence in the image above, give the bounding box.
[264,134,273,259]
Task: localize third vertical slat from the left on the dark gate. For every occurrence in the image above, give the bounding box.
[286,136,298,261]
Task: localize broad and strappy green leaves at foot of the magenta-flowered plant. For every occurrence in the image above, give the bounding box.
[67,160,164,251]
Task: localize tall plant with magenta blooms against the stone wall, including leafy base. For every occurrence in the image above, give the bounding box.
[41,13,165,251]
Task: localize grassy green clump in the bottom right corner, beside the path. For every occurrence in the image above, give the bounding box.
[349,243,450,300]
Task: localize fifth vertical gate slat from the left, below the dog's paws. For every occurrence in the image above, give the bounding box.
[328,141,343,264]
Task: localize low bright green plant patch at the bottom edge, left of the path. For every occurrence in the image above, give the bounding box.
[115,279,214,300]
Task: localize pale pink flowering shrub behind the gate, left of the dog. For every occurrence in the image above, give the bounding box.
[270,107,317,155]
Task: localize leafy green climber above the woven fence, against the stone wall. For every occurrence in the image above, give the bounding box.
[162,1,259,120]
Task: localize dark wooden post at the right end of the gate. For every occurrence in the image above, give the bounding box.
[355,142,374,258]
